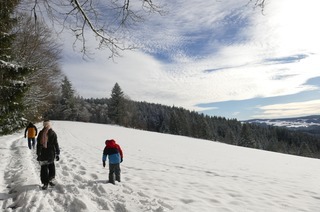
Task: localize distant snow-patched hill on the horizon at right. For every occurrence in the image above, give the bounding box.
[244,115,320,136]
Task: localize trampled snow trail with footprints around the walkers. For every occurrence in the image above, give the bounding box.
[0,127,171,212]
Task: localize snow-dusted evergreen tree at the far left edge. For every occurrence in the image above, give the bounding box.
[0,0,31,134]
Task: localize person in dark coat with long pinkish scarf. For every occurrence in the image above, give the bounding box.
[37,121,60,189]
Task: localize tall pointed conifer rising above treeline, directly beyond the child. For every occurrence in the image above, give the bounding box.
[108,83,125,125]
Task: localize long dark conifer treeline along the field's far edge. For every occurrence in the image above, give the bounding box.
[47,81,320,158]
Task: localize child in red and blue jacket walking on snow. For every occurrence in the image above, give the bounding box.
[102,139,123,184]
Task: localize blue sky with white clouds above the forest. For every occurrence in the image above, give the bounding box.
[62,0,320,120]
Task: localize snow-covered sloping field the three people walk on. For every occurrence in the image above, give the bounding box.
[0,121,320,212]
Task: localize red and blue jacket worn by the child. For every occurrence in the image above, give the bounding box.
[102,140,123,164]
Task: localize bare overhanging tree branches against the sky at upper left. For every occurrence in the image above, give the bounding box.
[23,0,163,58]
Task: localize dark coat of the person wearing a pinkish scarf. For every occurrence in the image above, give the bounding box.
[37,128,60,163]
